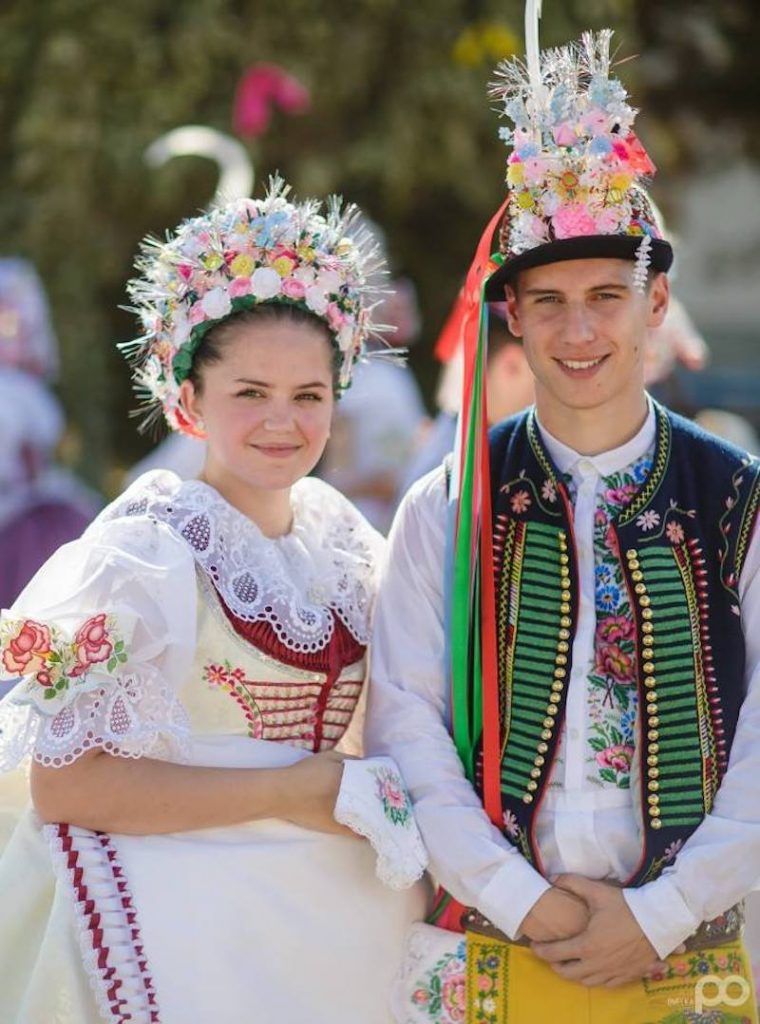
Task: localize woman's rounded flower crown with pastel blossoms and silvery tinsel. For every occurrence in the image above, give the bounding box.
[120,177,388,433]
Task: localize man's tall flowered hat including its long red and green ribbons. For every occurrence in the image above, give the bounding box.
[447,0,673,827]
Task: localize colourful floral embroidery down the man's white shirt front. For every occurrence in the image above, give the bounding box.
[566,452,652,790]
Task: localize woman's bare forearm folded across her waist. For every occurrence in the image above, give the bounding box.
[32,750,353,836]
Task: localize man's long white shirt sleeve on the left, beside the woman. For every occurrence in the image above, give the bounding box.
[366,468,549,938]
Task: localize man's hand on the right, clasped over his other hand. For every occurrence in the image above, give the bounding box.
[533,874,660,988]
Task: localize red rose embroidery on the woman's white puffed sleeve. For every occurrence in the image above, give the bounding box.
[0,612,127,714]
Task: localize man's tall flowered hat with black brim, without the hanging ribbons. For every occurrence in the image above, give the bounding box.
[485,0,673,300]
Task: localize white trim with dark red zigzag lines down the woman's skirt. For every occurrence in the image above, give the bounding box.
[43,825,160,1024]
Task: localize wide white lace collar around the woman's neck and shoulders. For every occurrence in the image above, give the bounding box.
[103,471,383,651]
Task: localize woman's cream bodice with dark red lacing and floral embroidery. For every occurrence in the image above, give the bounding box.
[186,572,366,752]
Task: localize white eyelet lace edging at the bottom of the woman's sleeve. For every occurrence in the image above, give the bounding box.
[0,666,191,773]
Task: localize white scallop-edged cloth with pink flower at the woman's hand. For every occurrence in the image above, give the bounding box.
[333,757,428,890]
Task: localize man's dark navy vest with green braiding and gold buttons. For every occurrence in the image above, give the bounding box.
[490,407,760,886]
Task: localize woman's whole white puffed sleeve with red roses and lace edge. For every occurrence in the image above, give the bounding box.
[0,518,196,771]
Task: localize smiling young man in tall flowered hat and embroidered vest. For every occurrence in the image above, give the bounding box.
[369,9,760,1024]
